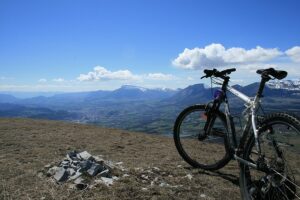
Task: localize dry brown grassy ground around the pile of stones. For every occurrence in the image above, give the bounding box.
[0,118,240,200]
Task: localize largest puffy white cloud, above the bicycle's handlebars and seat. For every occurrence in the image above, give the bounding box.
[172,43,283,69]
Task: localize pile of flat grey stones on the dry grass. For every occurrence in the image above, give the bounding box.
[45,151,118,190]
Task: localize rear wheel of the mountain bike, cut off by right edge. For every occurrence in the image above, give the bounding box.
[240,113,300,200]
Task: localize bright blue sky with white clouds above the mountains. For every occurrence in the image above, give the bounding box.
[0,0,300,91]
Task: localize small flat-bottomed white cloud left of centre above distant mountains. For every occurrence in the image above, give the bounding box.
[77,66,139,81]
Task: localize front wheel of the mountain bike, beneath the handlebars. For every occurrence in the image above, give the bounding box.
[173,105,230,170]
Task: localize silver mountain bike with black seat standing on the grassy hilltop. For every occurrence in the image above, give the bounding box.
[173,68,300,200]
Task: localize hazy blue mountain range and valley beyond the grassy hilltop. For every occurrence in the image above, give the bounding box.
[0,83,300,134]
